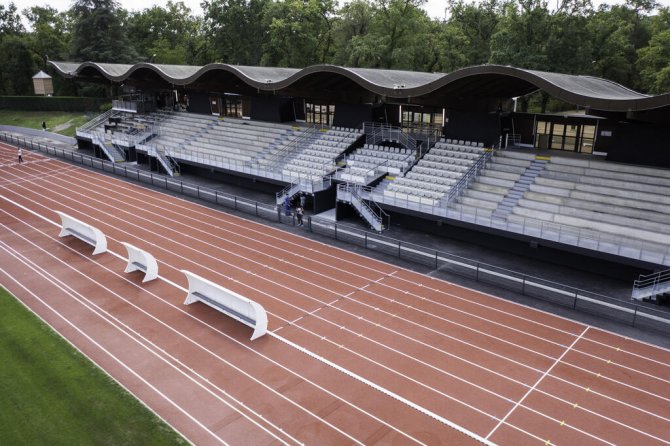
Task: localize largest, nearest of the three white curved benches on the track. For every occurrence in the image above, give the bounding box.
[182,270,268,341]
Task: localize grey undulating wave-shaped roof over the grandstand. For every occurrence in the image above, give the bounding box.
[49,61,670,111]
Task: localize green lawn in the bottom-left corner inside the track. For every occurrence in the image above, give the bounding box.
[0,288,188,446]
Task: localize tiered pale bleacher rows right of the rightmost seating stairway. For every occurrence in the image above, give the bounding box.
[509,156,670,245]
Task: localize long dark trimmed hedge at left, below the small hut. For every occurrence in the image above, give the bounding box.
[0,96,110,112]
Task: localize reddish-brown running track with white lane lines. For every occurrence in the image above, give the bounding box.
[0,145,670,446]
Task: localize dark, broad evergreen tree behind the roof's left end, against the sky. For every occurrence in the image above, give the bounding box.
[70,0,138,63]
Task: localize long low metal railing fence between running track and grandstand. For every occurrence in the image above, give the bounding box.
[0,133,670,333]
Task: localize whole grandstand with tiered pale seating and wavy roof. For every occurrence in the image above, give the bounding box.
[50,62,670,276]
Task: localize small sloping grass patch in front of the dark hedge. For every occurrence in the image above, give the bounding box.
[0,110,94,136]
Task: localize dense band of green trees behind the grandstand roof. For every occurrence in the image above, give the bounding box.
[0,0,670,95]
